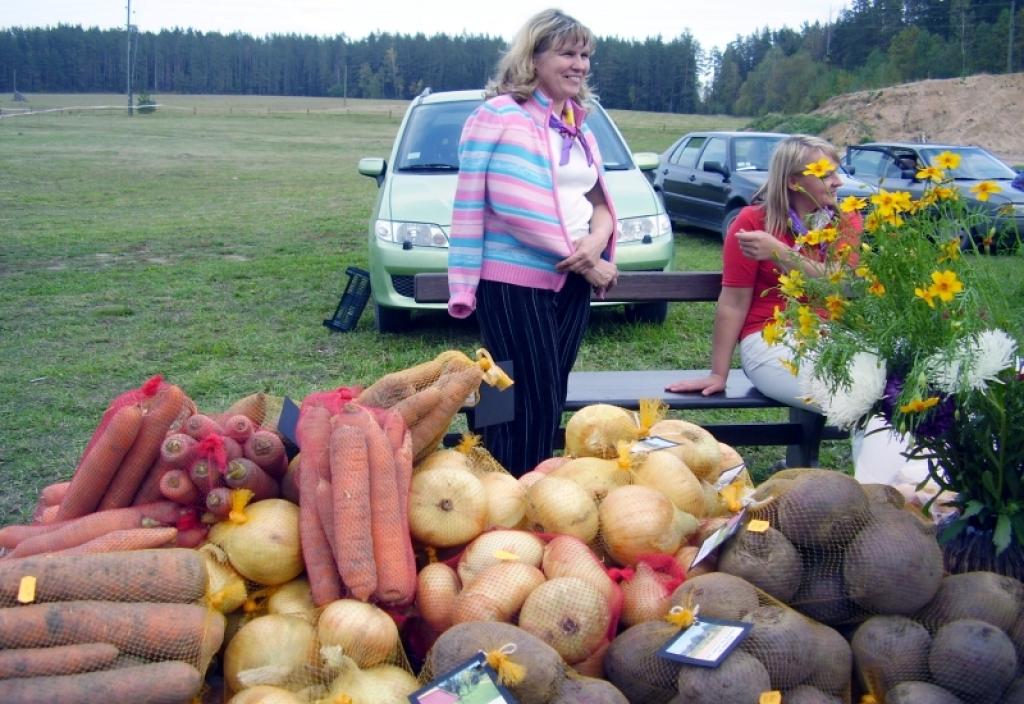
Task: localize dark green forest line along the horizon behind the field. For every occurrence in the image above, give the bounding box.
[0,0,1024,116]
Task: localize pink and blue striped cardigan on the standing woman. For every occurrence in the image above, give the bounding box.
[447,90,617,318]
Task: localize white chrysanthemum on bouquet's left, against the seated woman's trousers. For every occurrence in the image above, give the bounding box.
[800,352,886,429]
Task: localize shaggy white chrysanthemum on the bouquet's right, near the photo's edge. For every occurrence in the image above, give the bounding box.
[927,329,1017,394]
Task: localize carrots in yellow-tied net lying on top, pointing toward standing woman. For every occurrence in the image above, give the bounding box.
[355,349,512,461]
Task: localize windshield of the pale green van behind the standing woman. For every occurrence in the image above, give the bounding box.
[395,100,633,173]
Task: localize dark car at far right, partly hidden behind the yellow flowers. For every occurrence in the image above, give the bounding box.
[843,142,1024,241]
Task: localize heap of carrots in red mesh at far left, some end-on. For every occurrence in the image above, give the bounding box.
[0,376,298,557]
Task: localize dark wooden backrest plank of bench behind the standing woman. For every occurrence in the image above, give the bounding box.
[414,271,722,303]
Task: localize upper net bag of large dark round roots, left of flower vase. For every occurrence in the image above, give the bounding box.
[718,469,943,625]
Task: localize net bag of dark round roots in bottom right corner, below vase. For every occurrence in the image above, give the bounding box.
[851,572,1024,704]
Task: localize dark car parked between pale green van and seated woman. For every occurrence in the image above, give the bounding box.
[654,132,872,238]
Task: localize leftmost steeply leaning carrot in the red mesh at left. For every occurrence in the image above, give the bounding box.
[56,404,142,521]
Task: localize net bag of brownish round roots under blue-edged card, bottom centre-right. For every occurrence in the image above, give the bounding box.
[604,573,852,704]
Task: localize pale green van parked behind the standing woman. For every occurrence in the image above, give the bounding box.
[358,89,674,333]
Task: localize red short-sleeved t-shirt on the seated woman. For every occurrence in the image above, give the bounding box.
[722,206,860,340]
